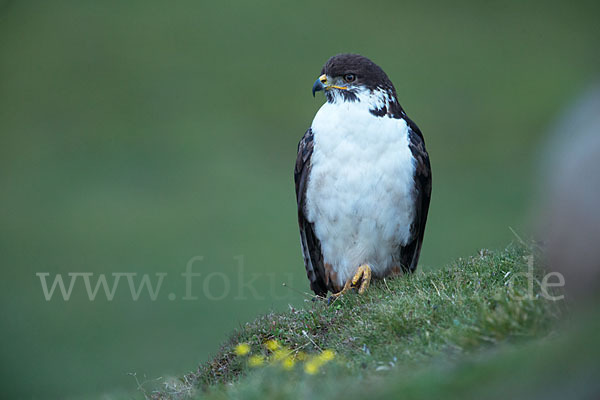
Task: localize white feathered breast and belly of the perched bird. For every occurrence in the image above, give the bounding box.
[306,95,415,285]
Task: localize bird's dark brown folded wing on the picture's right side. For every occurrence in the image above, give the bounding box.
[400,116,431,272]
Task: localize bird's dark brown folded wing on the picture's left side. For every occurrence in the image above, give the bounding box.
[294,128,327,296]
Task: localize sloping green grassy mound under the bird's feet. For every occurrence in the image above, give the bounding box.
[145,246,563,399]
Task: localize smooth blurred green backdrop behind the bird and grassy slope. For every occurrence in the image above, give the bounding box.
[0,0,600,399]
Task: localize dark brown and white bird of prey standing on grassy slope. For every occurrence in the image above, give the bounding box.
[294,54,431,296]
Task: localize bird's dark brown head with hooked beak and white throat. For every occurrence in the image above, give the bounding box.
[312,54,397,114]
